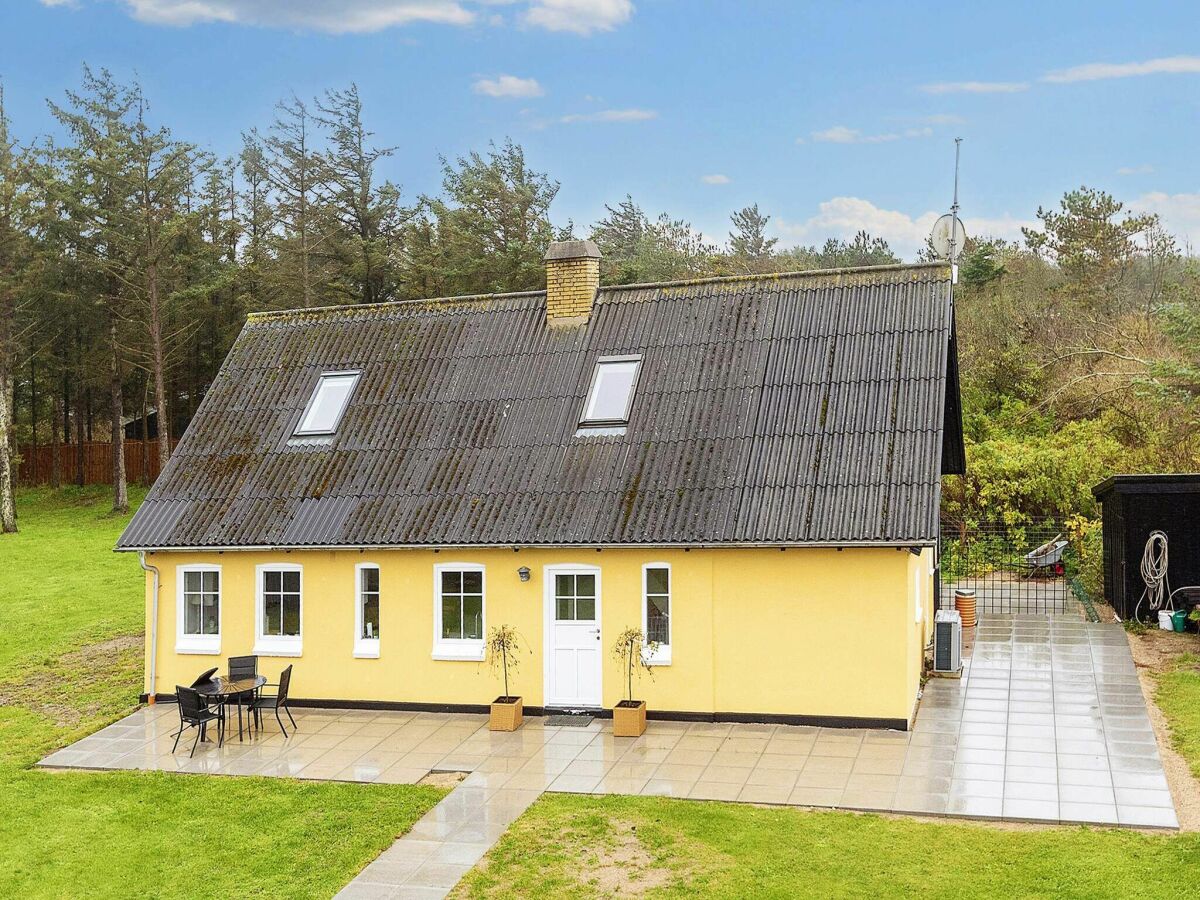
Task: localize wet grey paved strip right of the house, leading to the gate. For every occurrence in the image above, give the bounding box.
[905,614,1178,828]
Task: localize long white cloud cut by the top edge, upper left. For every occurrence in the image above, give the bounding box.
[122,0,475,34]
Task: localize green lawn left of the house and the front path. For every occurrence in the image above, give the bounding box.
[0,488,444,898]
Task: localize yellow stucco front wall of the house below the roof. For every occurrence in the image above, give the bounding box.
[145,548,932,720]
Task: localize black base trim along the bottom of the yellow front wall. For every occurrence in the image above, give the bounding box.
[139,694,908,731]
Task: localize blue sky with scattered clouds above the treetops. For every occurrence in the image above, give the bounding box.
[0,0,1200,256]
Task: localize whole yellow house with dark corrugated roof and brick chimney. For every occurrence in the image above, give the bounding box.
[118,241,964,728]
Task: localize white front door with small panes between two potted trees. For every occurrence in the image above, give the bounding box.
[546,565,602,708]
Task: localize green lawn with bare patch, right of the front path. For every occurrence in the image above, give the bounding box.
[456,794,1200,900]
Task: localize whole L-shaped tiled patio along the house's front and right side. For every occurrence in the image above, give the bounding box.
[41,616,1177,828]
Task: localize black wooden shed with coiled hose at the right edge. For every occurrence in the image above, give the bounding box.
[1092,474,1200,619]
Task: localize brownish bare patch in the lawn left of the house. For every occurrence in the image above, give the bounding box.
[0,635,143,728]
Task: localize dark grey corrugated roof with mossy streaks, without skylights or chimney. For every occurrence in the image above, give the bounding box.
[118,265,961,550]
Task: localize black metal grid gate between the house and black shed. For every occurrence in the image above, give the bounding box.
[940,520,1076,614]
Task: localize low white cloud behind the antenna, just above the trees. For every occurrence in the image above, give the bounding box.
[775,197,1036,259]
